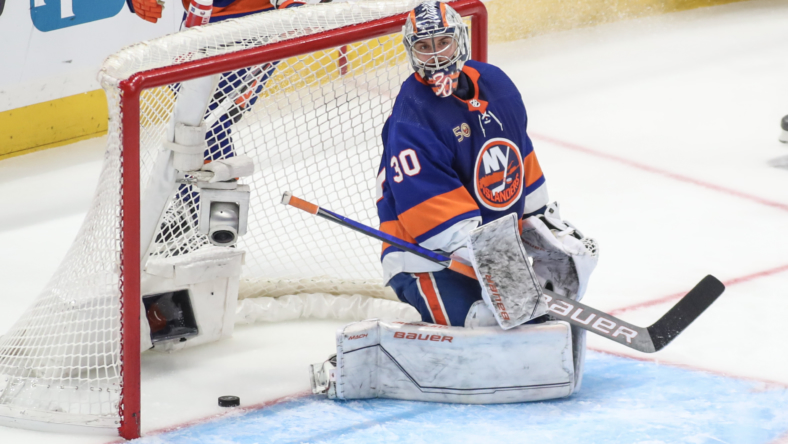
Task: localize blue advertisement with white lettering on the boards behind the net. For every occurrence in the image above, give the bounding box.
[31,0,126,32]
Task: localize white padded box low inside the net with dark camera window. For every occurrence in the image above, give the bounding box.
[140,245,244,352]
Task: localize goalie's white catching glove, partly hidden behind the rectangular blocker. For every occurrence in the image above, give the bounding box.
[520,202,599,301]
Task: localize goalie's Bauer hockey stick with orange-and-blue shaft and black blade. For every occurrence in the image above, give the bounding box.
[282,192,725,353]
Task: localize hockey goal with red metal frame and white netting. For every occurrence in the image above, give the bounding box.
[0,0,487,439]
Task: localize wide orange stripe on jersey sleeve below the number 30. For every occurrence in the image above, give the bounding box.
[399,187,479,237]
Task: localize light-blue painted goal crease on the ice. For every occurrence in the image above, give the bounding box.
[134,352,788,444]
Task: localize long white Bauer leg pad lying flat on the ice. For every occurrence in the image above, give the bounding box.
[312,319,575,404]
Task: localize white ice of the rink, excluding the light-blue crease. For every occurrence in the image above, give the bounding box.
[0,0,788,444]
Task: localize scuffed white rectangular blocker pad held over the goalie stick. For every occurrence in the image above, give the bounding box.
[468,213,547,330]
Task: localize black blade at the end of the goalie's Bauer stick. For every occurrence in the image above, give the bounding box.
[648,275,725,351]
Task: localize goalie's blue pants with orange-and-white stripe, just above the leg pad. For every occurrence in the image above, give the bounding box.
[389,270,482,327]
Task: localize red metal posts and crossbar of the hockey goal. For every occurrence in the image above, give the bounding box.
[118,0,487,439]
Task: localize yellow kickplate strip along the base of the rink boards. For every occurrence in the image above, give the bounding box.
[0,0,742,160]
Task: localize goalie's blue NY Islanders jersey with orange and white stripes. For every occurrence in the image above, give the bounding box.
[376,61,548,282]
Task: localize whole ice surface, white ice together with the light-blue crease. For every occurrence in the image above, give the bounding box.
[0,0,788,444]
